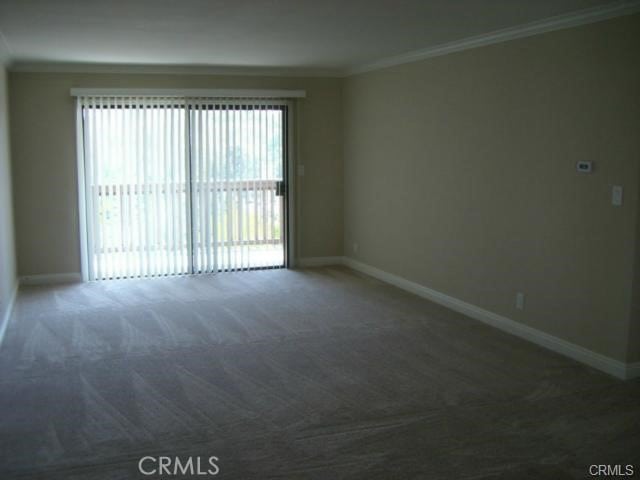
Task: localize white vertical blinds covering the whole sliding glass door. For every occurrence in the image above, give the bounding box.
[78,96,287,280]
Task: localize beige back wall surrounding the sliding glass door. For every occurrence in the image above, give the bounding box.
[11,72,343,275]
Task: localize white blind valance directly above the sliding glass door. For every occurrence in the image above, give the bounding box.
[70,88,307,98]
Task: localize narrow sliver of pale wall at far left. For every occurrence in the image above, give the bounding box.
[0,61,16,327]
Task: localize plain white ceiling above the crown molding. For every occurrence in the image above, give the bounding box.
[0,0,632,71]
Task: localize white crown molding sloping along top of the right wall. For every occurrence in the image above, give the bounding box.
[345,0,640,76]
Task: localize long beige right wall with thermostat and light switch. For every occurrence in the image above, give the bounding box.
[343,15,640,361]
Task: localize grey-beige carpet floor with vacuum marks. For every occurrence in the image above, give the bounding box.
[0,267,640,480]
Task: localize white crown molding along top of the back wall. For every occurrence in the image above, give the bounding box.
[9,61,344,77]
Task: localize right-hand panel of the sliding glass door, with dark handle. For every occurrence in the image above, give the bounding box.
[189,103,285,272]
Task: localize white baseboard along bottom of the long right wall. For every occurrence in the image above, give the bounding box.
[343,257,640,380]
